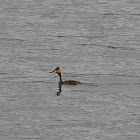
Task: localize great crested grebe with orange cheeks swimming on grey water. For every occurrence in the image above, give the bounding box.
[50,67,82,85]
